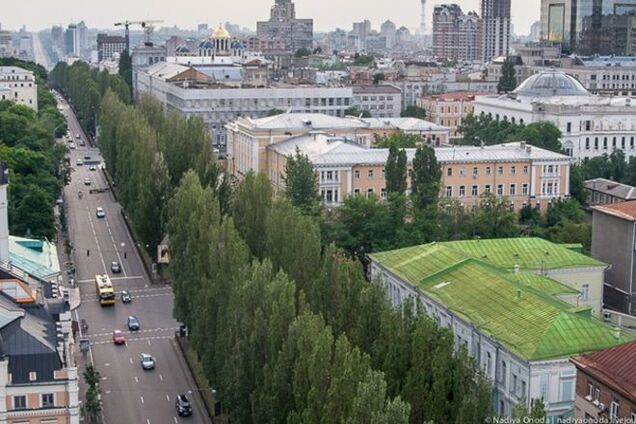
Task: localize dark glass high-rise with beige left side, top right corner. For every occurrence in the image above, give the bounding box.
[541,0,636,55]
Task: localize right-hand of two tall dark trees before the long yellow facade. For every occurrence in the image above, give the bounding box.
[411,146,442,209]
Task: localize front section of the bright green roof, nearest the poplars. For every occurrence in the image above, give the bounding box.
[370,242,631,361]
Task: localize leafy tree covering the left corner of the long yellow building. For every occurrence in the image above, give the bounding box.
[283,148,319,214]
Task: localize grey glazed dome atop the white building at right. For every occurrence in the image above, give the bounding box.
[513,71,591,97]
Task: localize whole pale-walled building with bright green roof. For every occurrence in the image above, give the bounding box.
[369,238,631,422]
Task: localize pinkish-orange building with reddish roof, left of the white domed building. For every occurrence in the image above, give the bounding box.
[417,91,489,138]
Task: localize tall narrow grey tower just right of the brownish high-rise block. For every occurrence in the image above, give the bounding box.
[481,0,511,62]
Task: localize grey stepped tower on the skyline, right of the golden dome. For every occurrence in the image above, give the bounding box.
[256,0,314,52]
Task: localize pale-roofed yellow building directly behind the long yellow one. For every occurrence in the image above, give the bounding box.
[226,113,449,178]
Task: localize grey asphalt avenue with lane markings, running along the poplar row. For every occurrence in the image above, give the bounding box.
[61,94,210,424]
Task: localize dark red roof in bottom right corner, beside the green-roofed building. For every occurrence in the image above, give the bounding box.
[570,341,636,402]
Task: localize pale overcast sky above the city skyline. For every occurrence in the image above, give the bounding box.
[0,0,540,34]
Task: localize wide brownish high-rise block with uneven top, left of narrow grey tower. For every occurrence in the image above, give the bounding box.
[433,4,482,62]
